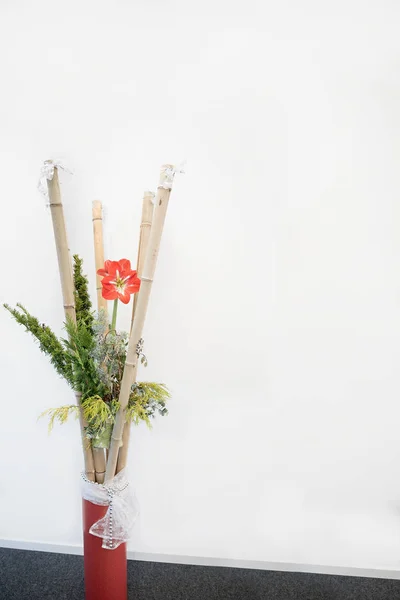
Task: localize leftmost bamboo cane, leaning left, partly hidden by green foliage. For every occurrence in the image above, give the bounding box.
[47,167,95,481]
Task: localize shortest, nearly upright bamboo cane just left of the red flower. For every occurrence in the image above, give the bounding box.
[92,200,107,483]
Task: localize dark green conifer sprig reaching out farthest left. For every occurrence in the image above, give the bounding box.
[3,304,73,385]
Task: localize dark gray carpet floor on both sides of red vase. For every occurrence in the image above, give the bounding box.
[0,548,400,600]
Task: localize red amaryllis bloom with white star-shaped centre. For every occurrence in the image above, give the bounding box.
[97,258,140,304]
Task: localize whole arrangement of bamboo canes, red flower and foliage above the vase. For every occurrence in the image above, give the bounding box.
[4,161,178,484]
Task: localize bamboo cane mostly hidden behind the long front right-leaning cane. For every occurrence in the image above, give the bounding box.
[117,191,153,473]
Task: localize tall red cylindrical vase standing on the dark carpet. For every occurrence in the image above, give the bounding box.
[83,500,128,600]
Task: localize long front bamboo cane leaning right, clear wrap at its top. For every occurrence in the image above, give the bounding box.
[105,165,172,482]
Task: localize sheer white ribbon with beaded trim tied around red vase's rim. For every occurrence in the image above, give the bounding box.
[82,469,139,550]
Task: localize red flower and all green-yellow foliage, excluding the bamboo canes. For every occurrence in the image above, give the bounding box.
[4,255,169,448]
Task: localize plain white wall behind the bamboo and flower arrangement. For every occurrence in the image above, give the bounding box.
[0,0,400,569]
